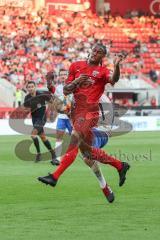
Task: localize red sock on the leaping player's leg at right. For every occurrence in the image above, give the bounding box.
[92,148,122,171]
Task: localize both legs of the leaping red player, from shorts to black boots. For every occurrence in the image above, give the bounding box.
[38,112,129,186]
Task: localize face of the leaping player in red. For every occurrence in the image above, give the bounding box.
[89,46,105,64]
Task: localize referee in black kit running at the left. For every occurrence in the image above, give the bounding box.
[24,78,59,165]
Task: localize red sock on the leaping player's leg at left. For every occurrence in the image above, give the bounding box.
[52,146,78,180]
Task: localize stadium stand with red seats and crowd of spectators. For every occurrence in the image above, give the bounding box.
[0,7,160,107]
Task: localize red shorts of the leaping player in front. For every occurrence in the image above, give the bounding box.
[71,106,99,145]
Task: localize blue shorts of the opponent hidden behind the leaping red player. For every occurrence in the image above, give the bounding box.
[92,128,108,148]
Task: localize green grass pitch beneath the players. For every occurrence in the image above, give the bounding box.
[0,132,160,240]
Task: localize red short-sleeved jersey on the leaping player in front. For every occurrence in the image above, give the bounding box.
[66,61,111,108]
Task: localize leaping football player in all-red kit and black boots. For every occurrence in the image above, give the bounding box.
[38,44,130,193]
